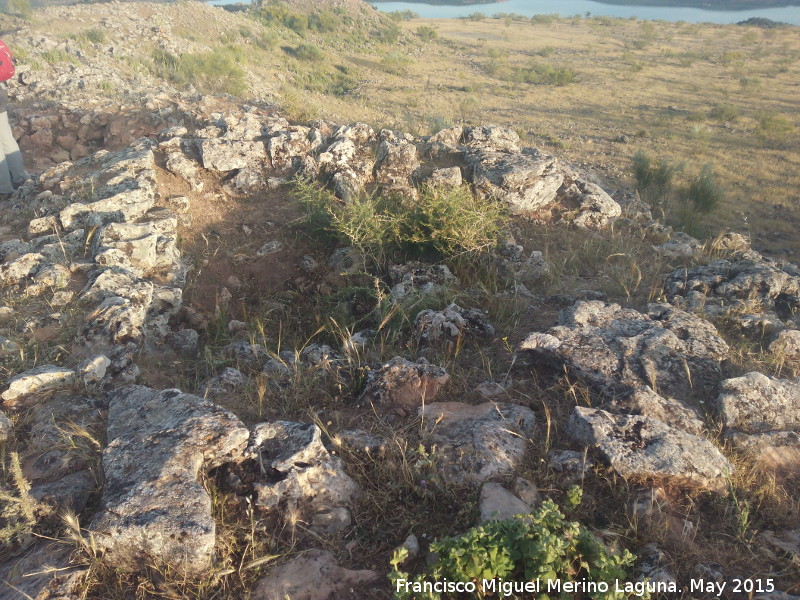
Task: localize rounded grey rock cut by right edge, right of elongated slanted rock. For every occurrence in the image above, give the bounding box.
[715,372,800,433]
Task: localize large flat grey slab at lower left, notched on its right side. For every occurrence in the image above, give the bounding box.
[90,386,249,577]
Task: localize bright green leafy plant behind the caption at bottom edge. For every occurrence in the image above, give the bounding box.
[388,500,636,600]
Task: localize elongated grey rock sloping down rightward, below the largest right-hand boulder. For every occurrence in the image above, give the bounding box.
[567,406,734,491]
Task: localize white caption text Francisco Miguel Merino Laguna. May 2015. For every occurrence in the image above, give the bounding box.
[395,579,775,597]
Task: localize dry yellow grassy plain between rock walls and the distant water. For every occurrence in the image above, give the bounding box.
[7,4,800,255]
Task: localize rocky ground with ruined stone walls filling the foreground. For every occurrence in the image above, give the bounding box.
[0,1,800,600]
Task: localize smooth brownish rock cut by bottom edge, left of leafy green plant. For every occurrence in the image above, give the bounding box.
[252,550,380,600]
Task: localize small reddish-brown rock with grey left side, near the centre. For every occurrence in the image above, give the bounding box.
[359,356,450,408]
